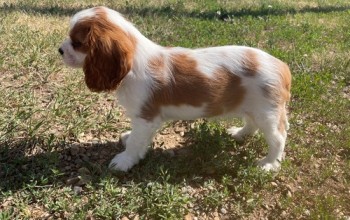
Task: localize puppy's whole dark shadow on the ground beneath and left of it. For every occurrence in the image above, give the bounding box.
[0,123,263,191]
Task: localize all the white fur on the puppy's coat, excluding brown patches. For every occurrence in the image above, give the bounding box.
[61,8,287,171]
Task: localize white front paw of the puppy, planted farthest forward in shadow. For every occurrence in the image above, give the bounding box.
[109,151,139,172]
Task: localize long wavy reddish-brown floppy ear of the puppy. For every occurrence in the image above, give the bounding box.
[83,15,135,92]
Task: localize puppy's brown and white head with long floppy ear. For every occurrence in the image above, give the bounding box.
[59,7,136,92]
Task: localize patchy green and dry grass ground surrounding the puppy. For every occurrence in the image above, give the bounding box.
[0,0,350,219]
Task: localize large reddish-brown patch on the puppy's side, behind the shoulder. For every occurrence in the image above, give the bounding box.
[141,53,245,120]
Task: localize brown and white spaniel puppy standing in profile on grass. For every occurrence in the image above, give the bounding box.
[58,7,291,171]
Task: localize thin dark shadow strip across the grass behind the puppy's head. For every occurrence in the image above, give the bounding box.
[0,4,350,20]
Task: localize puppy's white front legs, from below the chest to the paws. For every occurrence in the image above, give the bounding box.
[109,118,161,172]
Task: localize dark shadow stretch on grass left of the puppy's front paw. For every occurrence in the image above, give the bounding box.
[0,138,117,191]
